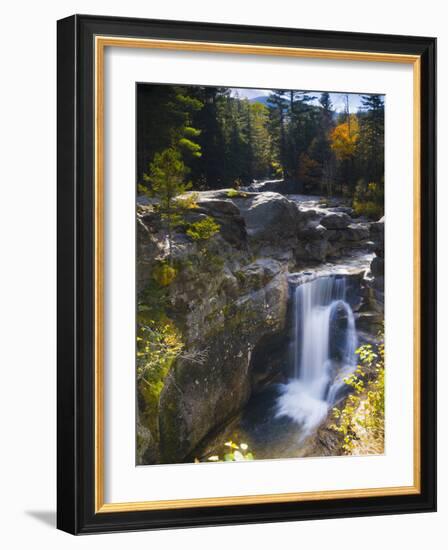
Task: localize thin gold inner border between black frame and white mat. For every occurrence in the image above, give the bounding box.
[94,36,421,513]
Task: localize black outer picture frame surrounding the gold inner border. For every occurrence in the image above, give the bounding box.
[57,15,436,534]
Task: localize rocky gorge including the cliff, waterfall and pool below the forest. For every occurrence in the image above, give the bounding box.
[137,181,384,464]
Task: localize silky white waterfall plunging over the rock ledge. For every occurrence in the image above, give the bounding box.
[277,275,357,436]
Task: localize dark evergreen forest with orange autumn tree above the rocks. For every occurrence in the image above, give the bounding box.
[137,84,384,219]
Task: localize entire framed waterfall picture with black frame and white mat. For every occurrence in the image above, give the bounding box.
[58,15,436,534]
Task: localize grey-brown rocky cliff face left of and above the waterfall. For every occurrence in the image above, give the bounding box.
[137,190,384,463]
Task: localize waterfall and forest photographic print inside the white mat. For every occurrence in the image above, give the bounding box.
[136,83,385,465]
